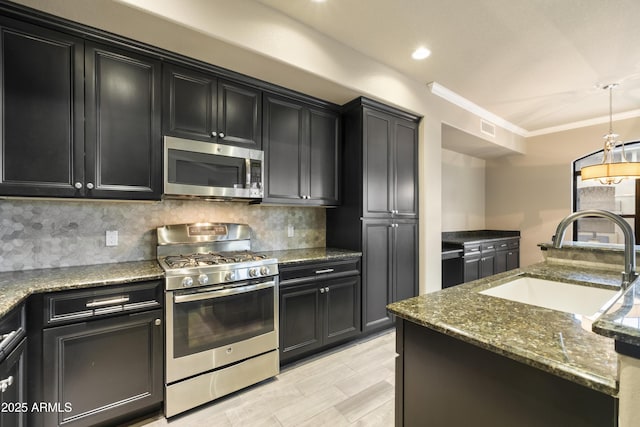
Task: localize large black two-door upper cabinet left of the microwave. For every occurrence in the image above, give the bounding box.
[0,18,161,199]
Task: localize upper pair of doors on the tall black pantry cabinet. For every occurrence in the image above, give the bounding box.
[362,107,418,218]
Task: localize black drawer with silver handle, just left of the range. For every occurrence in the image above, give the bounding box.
[44,280,163,324]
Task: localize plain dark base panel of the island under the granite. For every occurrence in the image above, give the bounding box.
[395,319,618,427]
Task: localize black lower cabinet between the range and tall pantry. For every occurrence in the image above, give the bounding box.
[280,261,360,363]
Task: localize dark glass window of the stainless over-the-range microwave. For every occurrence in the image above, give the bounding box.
[168,150,246,188]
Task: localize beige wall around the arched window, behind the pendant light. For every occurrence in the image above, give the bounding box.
[486,119,640,266]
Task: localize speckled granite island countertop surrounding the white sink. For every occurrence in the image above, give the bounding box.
[388,262,620,396]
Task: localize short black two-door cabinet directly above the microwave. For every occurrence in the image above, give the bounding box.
[163,64,262,149]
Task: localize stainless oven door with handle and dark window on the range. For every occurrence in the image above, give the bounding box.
[165,276,278,384]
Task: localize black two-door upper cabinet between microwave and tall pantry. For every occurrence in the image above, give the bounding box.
[263,94,340,206]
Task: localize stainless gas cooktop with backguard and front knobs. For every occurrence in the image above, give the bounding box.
[157,223,278,290]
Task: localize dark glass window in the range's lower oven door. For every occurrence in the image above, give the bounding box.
[173,288,274,358]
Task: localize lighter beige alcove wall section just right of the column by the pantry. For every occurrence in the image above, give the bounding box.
[442,149,486,231]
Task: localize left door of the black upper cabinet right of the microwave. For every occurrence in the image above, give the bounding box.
[263,95,304,204]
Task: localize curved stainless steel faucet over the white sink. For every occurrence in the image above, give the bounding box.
[552,209,638,289]
